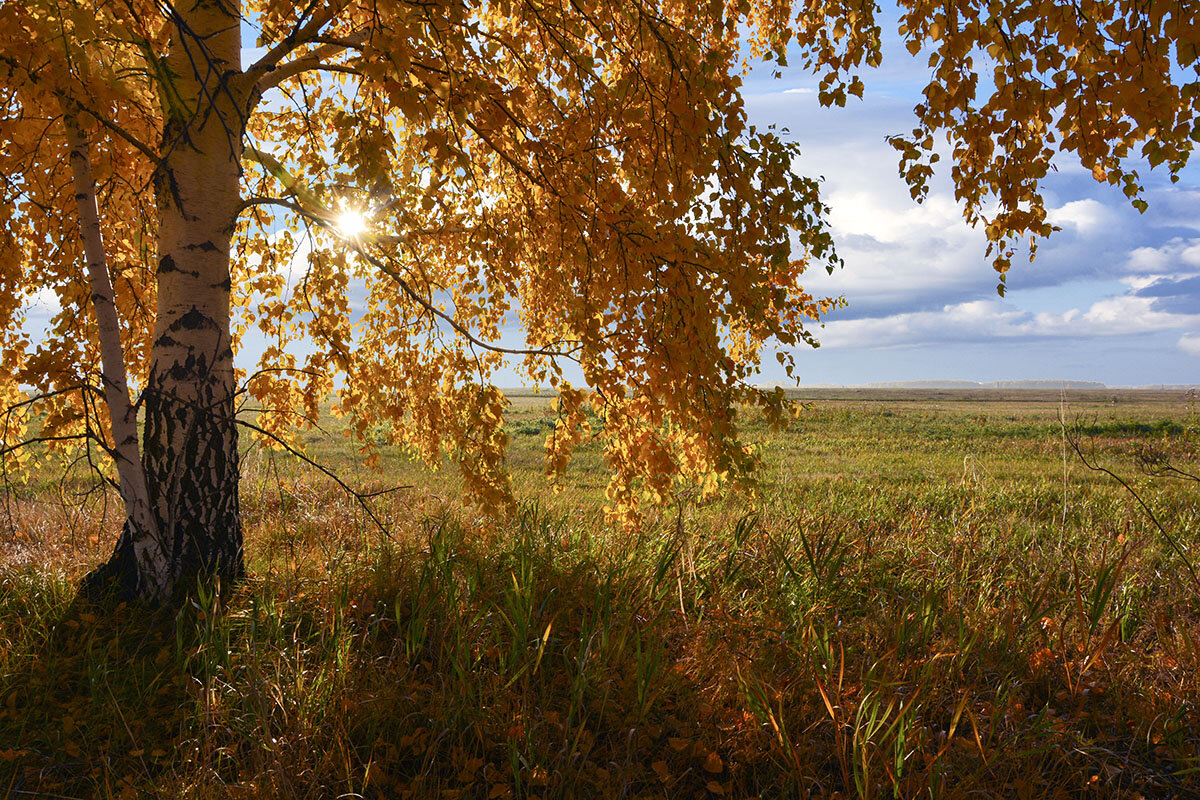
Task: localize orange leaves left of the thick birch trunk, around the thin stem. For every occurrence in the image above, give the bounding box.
[0,1,163,462]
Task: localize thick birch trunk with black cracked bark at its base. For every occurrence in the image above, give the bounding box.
[89,0,246,602]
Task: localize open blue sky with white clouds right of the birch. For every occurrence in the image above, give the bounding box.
[744,15,1200,384]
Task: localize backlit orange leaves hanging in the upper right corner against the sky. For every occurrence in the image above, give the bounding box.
[892,0,1200,283]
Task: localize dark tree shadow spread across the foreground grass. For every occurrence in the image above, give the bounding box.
[0,509,1195,800]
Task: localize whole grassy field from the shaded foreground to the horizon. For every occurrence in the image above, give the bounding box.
[0,390,1200,800]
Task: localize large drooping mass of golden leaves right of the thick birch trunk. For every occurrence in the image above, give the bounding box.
[231,2,834,519]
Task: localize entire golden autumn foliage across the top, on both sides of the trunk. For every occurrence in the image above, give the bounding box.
[0,0,1200,521]
